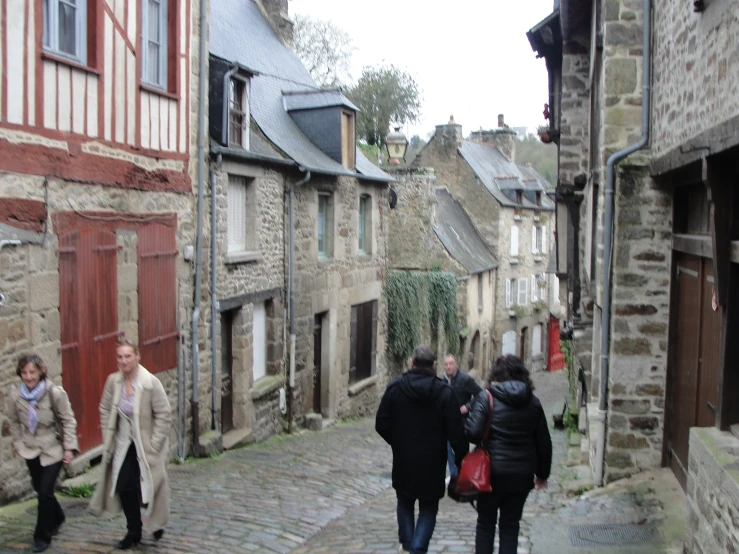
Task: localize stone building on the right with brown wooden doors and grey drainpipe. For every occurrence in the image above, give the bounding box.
[529,0,739,553]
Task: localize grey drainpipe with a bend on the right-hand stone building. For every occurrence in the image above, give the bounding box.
[594,0,652,486]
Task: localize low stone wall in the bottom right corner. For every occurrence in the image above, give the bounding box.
[683,428,739,554]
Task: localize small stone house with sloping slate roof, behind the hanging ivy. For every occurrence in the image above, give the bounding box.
[388,169,498,378]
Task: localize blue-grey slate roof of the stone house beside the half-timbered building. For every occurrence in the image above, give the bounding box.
[210,0,393,182]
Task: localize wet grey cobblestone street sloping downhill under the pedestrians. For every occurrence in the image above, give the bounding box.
[0,366,684,554]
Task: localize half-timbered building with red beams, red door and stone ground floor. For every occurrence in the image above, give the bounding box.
[0,0,200,502]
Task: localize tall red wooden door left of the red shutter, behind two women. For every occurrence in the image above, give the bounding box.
[59,228,120,452]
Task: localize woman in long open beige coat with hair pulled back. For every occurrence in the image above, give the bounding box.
[90,339,172,550]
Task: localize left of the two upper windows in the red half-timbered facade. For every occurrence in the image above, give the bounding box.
[42,0,87,65]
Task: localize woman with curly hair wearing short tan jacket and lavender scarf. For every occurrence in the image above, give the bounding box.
[7,354,79,552]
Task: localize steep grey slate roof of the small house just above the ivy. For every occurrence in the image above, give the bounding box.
[434,189,498,275]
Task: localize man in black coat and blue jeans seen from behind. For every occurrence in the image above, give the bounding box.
[375,346,467,554]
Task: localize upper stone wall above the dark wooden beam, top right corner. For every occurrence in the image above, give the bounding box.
[652,0,739,157]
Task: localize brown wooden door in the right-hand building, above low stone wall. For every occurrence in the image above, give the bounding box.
[666,252,720,488]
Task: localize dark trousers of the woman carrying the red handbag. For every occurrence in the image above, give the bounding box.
[475,491,529,554]
